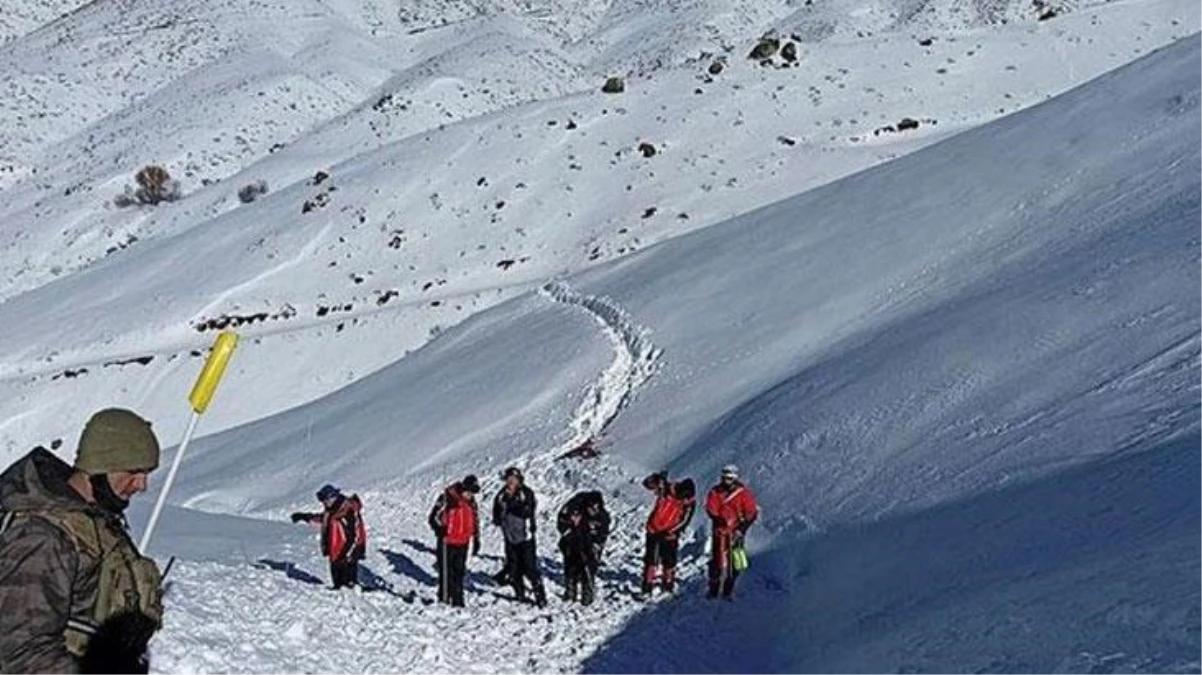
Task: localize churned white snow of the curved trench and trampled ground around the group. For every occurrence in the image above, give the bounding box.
[154,282,702,673]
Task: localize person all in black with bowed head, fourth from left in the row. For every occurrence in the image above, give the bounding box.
[555,491,612,605]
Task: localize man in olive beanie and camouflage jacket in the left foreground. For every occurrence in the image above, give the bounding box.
[0,408,162,673]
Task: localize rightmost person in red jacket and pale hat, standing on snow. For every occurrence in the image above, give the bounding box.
[706,464,760,599]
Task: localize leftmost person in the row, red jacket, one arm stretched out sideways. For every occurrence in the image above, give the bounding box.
[292,485,368,590]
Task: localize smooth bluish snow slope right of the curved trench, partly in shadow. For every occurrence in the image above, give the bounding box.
[583,30,1202,673]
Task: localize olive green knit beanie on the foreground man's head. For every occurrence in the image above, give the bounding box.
[76,408,159,476]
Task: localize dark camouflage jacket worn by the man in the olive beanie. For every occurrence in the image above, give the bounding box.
[0,449,159,675]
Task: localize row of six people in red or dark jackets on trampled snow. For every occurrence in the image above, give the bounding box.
[292,465,758,608]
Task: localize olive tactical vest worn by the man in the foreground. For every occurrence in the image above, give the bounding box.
[0,510,162,656]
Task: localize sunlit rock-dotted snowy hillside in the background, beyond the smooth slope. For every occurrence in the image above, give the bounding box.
[0,0,1202,458]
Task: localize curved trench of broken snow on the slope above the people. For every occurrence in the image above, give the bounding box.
[540,281,664,456]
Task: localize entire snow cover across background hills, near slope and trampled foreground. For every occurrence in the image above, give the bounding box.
[0,0,1202,674]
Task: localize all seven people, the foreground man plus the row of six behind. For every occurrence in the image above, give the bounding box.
[0,408,758,674]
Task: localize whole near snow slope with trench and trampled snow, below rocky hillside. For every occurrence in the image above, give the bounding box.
[114,28,1202,673]
